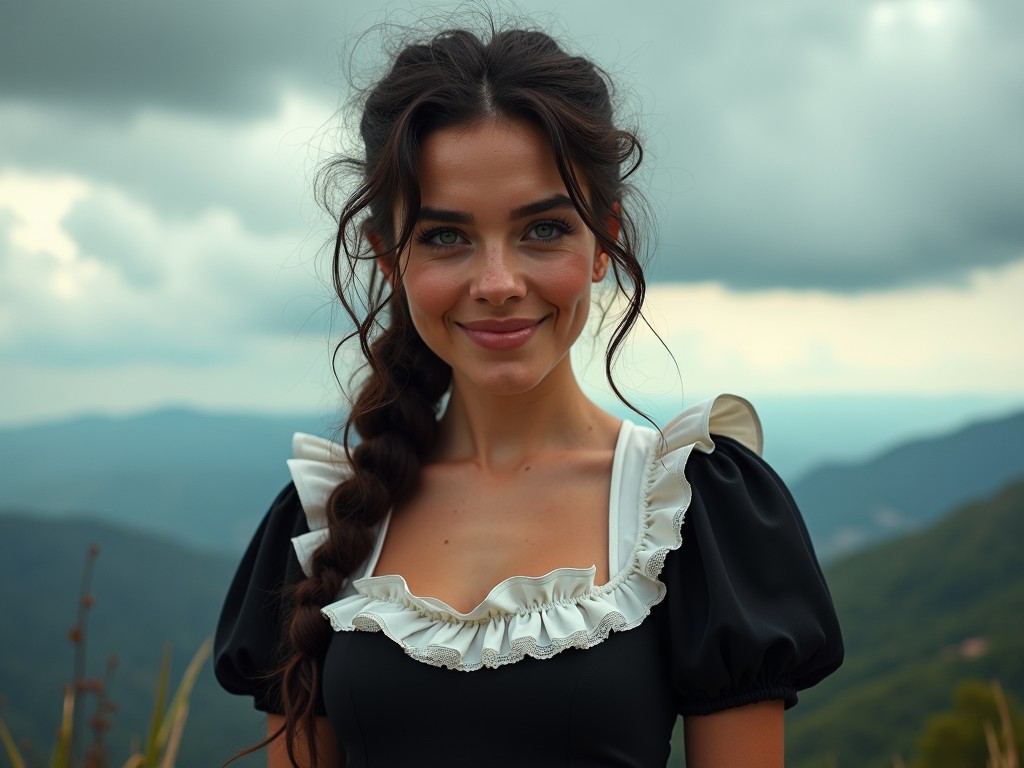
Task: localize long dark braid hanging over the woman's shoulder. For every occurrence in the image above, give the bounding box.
[282,290,452,768]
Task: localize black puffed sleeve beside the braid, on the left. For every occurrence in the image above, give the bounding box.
[213,484,324,715]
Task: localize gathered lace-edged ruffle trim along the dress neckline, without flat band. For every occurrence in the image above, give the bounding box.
[293,395,762,672]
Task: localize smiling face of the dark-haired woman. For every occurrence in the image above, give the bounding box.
[387,120,607,394]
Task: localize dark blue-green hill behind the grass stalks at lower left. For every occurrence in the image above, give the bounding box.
[0,515,266,768]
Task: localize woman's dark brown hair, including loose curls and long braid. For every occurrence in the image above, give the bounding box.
[281,20,645,766]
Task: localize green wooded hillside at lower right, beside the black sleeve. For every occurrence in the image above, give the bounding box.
[786,480,1024,768]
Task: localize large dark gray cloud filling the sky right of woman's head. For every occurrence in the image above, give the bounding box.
[630,2,1024,291]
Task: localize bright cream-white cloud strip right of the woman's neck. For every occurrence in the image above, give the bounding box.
[585,260,1024,398]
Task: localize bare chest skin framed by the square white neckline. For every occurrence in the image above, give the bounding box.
[373,452,612,612]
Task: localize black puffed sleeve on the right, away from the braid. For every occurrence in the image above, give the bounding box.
[662,435,843,716]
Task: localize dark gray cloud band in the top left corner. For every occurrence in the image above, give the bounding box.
[0,0,357,116]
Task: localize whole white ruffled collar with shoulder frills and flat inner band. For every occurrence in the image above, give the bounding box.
[288,395,762,672]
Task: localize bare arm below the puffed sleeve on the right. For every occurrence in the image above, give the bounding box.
[683,701,784,768]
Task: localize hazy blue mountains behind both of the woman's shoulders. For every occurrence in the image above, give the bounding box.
[0,411,1024,560]
